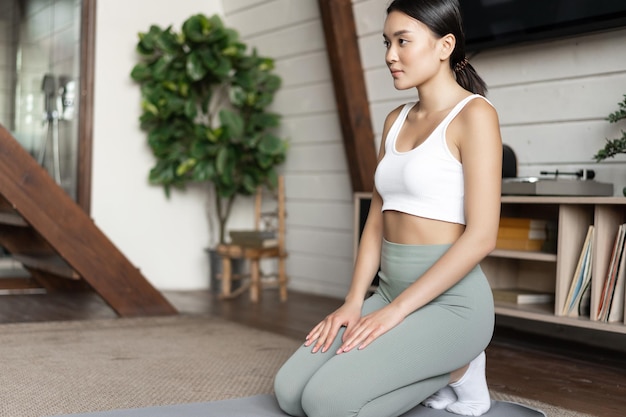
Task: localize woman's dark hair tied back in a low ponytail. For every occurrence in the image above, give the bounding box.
[387,0,487,95]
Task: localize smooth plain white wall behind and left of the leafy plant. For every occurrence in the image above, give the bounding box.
[92,0,222,289]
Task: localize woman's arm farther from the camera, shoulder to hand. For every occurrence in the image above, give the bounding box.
[304,107,401,353]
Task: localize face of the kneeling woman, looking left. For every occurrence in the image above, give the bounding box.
[383,11,442,90]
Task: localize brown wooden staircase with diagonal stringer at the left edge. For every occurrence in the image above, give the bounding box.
[0,125,176,317]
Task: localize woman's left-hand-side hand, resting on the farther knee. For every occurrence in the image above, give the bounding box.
[304,303,361,353]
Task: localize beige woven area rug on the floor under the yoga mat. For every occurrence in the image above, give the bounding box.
[0,316,589,417]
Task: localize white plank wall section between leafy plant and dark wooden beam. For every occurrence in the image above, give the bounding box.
[224,0,353,297]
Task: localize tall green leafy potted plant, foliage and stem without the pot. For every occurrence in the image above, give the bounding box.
[131,14,287,243]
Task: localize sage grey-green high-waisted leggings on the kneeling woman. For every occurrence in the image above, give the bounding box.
[274,241,494,417]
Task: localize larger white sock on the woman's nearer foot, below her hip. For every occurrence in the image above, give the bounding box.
[446,352,491,416]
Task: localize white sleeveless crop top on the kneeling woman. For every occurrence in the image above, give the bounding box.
[374,94,486,224]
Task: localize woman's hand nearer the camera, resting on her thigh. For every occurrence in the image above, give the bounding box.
[337,304,405,354]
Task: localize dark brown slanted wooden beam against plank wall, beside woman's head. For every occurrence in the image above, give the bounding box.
[319,0,377,192]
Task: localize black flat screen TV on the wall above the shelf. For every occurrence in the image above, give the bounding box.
[460,0,626,52]
